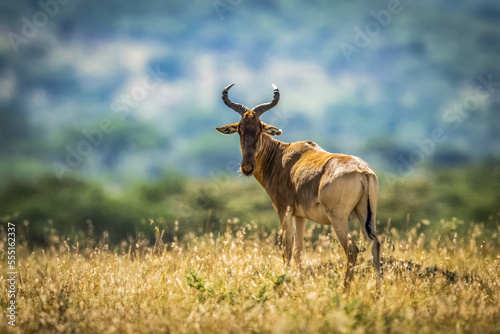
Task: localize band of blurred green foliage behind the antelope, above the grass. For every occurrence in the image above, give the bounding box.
[0,163,500,245]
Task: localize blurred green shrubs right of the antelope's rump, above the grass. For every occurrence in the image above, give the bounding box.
[377,160,500,234]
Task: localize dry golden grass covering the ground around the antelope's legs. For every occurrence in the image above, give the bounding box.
[0,222,500,333]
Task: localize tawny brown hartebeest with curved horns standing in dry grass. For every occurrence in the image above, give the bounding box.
[216,84,380,282]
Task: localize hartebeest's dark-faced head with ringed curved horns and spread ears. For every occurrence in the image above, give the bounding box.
[215,84,281,176]
